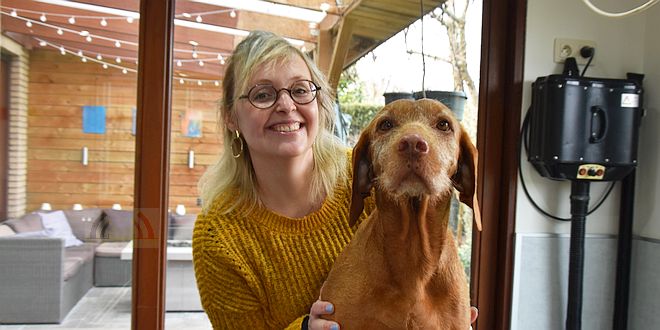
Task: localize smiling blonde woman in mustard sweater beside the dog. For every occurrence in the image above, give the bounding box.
[193,32,354,329]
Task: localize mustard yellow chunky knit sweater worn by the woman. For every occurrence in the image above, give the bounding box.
[193,174,365,330]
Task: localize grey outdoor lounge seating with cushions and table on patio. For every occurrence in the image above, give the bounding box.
[0,208,196,324]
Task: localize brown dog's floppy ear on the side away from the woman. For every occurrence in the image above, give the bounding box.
[452,130,481,231]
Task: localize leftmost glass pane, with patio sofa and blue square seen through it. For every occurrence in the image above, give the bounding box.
[0,0,139,329]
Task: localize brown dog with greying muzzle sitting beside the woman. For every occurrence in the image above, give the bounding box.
[320,99,481,330]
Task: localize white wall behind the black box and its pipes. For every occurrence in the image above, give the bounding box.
[511,0,660,330]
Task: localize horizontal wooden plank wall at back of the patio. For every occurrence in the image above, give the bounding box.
[27,49,222,213]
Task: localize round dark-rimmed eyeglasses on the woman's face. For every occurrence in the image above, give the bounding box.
[238,80,321,109]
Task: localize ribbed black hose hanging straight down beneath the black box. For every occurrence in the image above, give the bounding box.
[566,180,589,330]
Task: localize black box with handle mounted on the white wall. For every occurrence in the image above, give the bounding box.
[528,75,643,181]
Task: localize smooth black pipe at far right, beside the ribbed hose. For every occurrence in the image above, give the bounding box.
[612,169,635,330]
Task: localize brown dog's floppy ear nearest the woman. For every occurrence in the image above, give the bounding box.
[348,128,372,227]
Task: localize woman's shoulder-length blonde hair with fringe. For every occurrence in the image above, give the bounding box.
[198,31,347,213]
